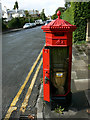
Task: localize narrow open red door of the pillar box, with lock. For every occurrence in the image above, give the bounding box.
[43,48,50,102]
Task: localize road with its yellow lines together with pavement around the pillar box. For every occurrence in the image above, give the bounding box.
[2,26,90,120]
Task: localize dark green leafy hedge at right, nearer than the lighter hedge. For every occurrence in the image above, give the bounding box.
[74,2,90,42]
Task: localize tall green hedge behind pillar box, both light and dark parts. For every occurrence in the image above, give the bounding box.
[63,2,90,42]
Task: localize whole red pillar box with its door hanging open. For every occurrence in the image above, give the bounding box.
[41,11,76,102]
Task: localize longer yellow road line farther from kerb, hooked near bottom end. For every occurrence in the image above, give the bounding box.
[5,50,42,118]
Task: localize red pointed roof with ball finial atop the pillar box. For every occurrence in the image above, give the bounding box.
[42,11,76,31]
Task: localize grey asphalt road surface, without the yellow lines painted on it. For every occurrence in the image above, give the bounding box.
[2,26,45,118]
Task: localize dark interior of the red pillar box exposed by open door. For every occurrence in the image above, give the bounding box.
[50,47,70,97]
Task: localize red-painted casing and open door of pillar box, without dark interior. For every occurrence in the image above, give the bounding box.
[41,11,76,102]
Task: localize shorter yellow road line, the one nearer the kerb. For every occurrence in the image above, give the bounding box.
[20,59,43,112]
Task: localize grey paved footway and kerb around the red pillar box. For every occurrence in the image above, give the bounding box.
[36,43,90,120]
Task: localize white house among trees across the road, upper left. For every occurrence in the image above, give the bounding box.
[2,7,26,21]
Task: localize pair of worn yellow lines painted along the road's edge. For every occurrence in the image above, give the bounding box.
[4,50,42,120]
